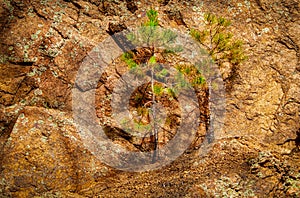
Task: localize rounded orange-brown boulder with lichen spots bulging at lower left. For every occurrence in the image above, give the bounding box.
[1,107,111,197]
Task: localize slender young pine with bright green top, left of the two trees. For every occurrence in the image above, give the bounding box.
[122,9,205,163]
